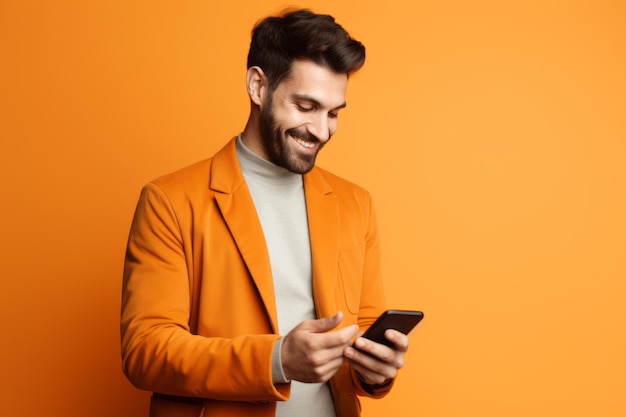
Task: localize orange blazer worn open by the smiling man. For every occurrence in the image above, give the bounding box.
[121,139,390,417]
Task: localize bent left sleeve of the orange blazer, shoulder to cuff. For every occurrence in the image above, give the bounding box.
[121,183,289,402]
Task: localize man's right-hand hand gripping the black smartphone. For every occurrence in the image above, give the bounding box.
[344,329,409,385]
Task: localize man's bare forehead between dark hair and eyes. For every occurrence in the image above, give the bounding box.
[276,60,348,108]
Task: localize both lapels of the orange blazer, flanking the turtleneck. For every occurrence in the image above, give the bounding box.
[210,138,339,324]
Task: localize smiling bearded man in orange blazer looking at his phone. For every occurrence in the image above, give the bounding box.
[121,10,408,417]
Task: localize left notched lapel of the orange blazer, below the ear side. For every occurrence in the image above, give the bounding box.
[210,138,278,332]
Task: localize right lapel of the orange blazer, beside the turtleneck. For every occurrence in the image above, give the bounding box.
[304,168,339,317]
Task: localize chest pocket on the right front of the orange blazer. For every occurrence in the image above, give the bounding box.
[338,245,365,314]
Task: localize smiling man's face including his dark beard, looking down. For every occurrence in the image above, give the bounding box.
[260,61,348,174]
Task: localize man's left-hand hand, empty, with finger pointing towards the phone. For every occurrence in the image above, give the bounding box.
[281,311,359,382]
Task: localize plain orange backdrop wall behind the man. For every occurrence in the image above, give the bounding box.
[0,0,626,417]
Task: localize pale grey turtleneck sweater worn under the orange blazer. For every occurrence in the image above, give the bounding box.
[237,135,336,417]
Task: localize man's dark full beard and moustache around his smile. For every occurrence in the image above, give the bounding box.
[259,96,326,174]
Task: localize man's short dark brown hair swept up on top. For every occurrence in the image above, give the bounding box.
[248,9,365,91]
